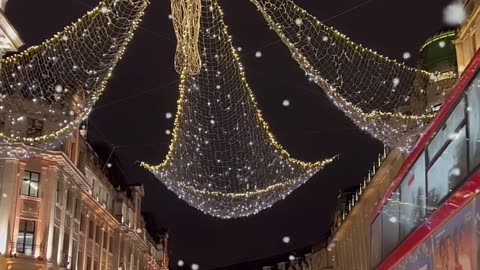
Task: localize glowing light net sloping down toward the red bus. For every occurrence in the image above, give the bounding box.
[251,0,435,151]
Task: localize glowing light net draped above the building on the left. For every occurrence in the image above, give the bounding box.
[0,0,148,149]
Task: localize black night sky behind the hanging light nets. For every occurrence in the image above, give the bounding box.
[7,0,450,269]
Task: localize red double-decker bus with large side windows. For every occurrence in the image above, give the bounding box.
[371,49,480,270]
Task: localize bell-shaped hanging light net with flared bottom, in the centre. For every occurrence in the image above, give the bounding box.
[143,0,332,218]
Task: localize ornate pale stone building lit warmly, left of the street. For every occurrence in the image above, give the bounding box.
[0,130,168,270]
